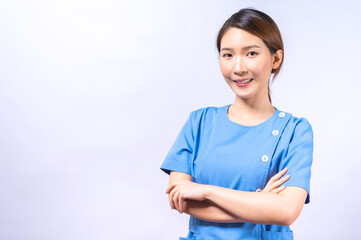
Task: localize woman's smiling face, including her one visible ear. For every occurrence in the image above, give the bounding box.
[220,28,282,100]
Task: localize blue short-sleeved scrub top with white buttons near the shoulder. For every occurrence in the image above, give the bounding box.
[161,104,313,240]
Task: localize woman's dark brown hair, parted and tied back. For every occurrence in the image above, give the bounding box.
[217,8,284,101]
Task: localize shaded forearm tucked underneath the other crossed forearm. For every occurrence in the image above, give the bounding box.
[184,200,244,223]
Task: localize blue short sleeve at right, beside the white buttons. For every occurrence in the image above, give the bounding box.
[280,118,313,203]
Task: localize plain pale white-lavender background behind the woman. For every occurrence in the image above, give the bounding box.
[0,0,361,240]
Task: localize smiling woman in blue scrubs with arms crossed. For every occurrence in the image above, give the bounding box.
[161,8,313,240]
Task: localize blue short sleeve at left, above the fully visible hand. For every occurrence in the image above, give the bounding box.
[160,113,194,175]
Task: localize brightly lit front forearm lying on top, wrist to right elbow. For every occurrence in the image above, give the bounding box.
[202,185,304,225]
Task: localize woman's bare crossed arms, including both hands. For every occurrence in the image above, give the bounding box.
[166,169,307,225]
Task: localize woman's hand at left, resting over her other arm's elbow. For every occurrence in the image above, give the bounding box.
[166,180,207,213]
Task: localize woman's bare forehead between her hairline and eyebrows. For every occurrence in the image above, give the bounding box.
[221,28,266,48]
